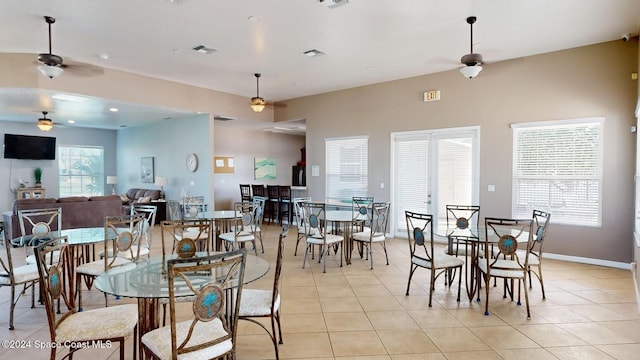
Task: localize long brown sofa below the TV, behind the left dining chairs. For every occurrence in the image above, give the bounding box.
[2,195,124,239]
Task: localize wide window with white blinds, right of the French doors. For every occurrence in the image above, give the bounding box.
[512,118,604,226]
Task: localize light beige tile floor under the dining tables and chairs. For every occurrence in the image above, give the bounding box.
[0,226,640,360]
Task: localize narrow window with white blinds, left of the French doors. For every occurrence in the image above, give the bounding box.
[325,137,369,202]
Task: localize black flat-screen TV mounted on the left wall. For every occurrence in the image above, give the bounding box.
[4,134,56,160]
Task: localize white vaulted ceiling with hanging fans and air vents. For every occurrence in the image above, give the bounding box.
[0,0,640,127]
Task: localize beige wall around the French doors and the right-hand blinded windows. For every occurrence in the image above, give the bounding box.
[276,41,638,264]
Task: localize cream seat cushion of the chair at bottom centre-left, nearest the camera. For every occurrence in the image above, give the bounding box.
[142,319,233,360]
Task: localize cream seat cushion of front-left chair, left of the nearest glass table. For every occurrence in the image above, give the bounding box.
[56,304,138,342]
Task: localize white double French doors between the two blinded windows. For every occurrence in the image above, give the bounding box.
[391,127,480,237]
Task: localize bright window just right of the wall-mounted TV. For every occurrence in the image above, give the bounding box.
[58,146,105,197]
